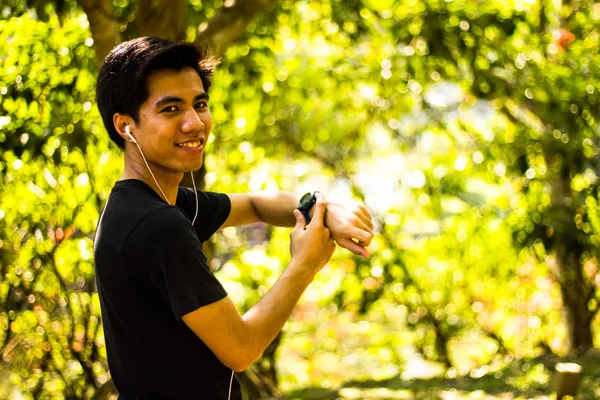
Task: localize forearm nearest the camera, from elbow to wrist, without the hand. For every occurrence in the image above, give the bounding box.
[242,264,314,365]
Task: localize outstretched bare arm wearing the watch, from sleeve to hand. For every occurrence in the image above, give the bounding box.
[221,191,373,258]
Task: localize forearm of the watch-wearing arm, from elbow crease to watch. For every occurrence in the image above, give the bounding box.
[251,191,301,226]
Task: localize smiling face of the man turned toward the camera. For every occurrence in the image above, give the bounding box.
[134,68,212,173]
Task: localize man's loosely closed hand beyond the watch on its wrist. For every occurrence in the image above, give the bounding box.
[325,202,373,259]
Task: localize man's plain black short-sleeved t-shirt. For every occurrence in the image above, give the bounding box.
[94,179,241,400]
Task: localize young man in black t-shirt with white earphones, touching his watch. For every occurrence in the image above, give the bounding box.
[94,37,373,399]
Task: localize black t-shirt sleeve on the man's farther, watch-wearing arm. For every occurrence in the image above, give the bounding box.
[180,188,231,242]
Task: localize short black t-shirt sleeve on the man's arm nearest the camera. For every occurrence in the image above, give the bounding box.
[125,208,227,319]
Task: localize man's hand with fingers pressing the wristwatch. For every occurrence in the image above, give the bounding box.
[290,194,335,274]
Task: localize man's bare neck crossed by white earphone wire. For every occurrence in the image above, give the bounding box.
[120,145,183,205]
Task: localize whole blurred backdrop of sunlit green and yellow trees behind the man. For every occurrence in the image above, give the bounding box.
[0,0,600,399]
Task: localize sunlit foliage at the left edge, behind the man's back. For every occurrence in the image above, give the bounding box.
[0,8,118,398]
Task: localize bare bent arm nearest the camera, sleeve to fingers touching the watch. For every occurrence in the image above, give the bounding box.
[182,196,335,371]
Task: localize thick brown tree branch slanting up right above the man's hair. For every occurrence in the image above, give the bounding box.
[194,0,277,57]
